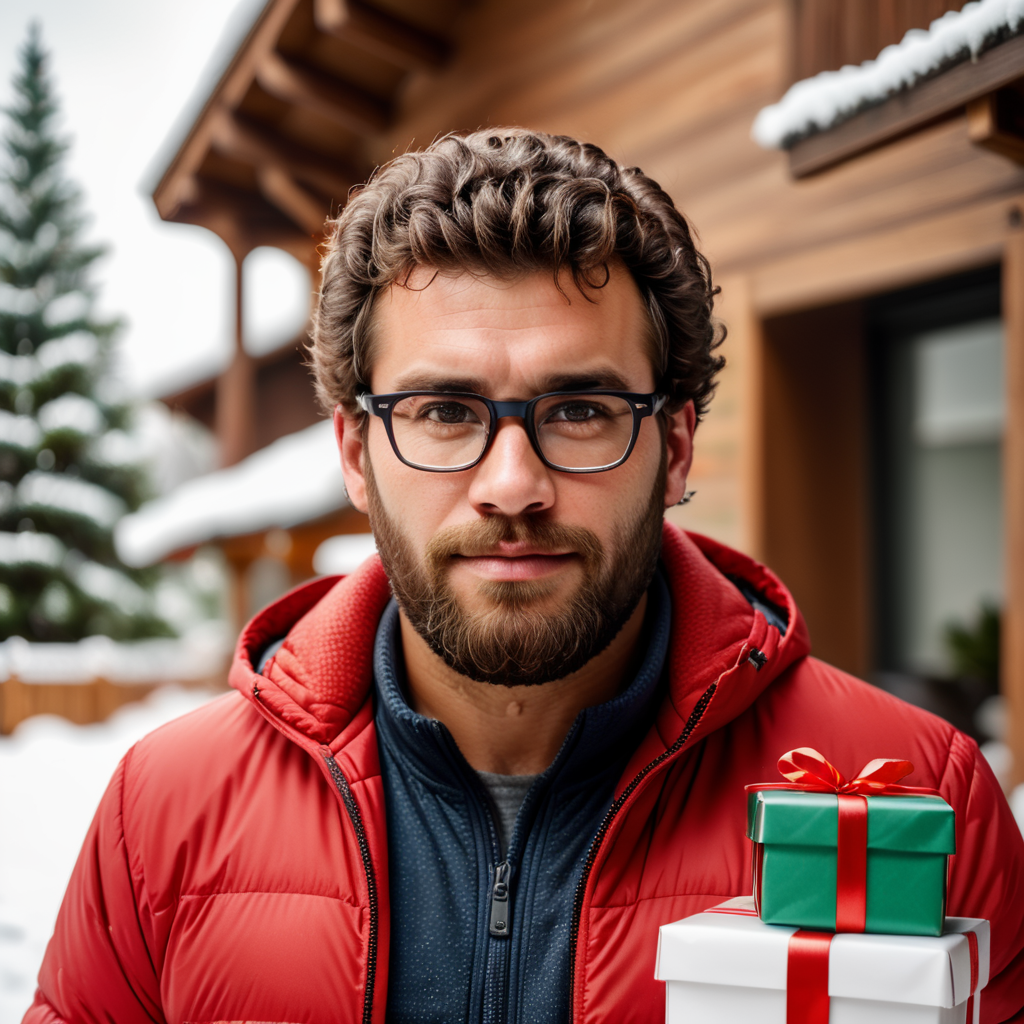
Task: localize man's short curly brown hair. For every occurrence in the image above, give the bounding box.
[309,128,725,418]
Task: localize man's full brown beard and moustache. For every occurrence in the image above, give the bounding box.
[365,457,666,686]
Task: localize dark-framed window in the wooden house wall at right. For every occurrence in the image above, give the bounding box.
[867,267,1005,731]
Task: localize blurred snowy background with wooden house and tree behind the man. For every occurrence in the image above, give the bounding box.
[0,0,1024,1022]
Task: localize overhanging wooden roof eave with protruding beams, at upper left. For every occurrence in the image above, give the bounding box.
[154,0,450,251]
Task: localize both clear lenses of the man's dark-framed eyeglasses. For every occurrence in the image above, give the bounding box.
[391,394,633,469]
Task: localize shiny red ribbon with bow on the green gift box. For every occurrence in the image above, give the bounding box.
[745,746,939,934]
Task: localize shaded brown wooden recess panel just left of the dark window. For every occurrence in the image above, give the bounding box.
[760,302,871,676]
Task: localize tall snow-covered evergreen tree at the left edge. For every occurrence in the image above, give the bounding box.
[0,27,170,641]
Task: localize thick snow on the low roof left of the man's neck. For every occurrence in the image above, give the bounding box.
[115,420,346,565]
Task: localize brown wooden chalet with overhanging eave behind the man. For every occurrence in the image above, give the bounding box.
[154,0,1024,781]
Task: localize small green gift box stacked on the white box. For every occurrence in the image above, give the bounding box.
[746,788,955,935]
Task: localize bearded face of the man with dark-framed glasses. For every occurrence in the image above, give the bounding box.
[338,267,692,685]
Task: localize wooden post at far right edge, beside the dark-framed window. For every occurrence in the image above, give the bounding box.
[1000,232,1024,785]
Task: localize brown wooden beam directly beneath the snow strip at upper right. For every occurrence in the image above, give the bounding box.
[790,36,1024,178]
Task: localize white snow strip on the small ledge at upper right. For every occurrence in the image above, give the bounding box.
[752,0,1024,150]
